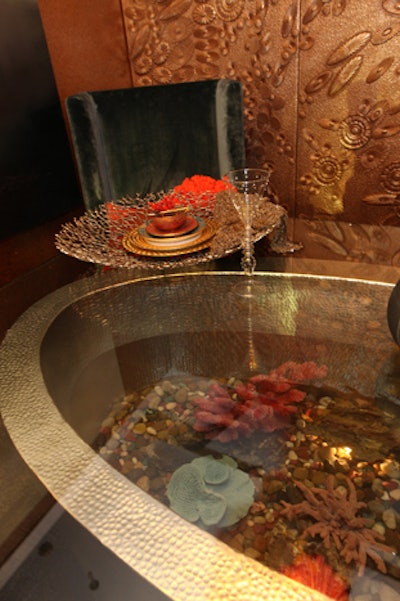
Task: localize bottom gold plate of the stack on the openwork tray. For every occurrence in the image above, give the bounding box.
[122,220,216,257]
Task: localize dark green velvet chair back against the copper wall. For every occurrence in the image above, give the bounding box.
[66,79,245,209]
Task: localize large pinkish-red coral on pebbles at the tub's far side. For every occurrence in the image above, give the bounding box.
[193,362,327,442]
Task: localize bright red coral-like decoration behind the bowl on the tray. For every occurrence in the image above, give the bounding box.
[149,175,235,213]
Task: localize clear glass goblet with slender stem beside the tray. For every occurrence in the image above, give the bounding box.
[227,167,271,276]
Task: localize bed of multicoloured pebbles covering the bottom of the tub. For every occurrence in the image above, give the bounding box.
[94,376,400,601]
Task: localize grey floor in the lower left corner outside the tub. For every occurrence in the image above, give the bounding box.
[0,505,168,601]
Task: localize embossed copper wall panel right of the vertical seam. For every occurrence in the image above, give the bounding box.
[296,0,400,223]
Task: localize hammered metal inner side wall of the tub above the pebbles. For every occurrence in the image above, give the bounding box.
[41,277,393,443]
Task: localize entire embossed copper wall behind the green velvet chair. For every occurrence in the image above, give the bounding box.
[39,0,400,263]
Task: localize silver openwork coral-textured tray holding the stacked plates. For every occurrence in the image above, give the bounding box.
[55,192,297,271]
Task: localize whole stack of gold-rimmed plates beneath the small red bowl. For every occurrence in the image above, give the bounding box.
[122,215,215,257]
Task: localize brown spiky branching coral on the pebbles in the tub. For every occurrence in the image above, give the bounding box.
[282,475,393,575]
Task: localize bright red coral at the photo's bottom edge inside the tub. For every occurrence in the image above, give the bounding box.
[282,553,349,601]
